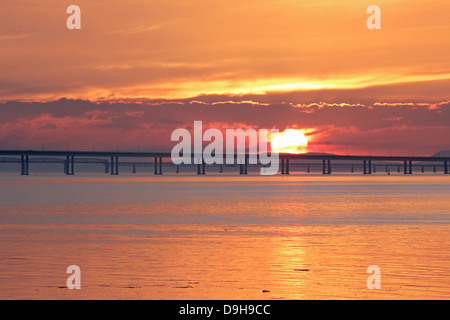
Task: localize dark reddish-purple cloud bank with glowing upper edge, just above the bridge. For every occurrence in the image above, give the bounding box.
[0,96,450,155]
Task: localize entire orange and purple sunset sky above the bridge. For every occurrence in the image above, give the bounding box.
[0,0,450,155]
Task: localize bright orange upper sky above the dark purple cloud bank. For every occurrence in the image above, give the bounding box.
[0,0,450,101]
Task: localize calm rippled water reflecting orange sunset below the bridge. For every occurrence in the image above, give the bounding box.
[0,174,450,300]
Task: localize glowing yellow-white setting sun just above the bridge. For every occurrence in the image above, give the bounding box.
[270,129,308,153]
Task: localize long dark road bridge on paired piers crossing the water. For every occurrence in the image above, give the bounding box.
[0,150,450,175]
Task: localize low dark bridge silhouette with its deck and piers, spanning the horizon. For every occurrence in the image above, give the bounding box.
[0,150,450,175]
